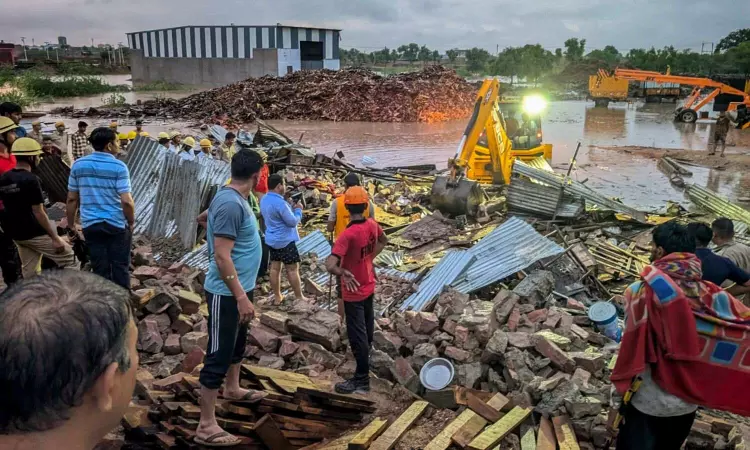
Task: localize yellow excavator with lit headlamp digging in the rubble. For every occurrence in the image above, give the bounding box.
[430,79,552,216]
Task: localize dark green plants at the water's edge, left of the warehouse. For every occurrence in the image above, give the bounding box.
[15,72,130,97]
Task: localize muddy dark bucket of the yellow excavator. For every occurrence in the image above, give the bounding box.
[430,176,484,217]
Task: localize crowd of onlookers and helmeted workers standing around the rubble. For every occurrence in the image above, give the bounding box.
[0,99,750,450]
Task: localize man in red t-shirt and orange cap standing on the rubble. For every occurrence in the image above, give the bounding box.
[326,186,388,394]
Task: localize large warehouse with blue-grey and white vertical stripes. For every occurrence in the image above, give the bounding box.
[128,24,340,87]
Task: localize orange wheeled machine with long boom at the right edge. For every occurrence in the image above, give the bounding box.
[615,69,750,130]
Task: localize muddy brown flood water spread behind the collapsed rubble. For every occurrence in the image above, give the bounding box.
[38,86,750,210]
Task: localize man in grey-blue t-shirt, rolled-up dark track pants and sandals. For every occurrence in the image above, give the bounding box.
[195,150,266,447]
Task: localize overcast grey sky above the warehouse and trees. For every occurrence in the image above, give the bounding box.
[0,0,750,53]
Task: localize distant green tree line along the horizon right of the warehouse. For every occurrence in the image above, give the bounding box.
[341,28,750,83]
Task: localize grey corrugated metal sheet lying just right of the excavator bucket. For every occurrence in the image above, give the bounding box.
[506,178,584,219]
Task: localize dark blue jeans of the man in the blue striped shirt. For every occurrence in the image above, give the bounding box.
[83,222,132,290]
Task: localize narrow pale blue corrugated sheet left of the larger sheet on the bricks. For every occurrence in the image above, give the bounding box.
[400,250,475,311]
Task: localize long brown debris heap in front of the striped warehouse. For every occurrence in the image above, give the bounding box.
[53,66,475,124]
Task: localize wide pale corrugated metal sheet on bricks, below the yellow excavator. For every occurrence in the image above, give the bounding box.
[452,217,563,294]
